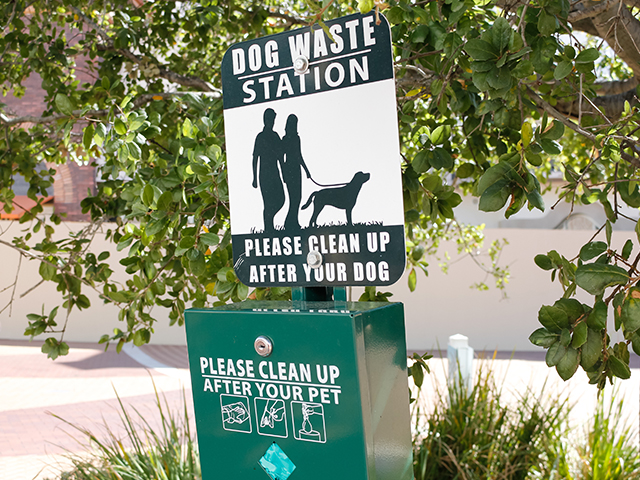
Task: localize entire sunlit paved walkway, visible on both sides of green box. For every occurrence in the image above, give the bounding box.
[0,340,640,480]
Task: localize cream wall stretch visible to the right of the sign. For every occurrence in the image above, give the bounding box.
[370,229,637,351]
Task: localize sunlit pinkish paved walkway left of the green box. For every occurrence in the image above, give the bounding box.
[0,340,192,480]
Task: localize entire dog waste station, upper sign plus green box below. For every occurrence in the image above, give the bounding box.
[185,12,413,480]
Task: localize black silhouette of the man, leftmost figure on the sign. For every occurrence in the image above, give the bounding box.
[253,108,284,232]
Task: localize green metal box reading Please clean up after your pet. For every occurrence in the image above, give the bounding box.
[186,301,413,480]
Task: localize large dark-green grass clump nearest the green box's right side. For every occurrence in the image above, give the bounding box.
[414,369,571,480]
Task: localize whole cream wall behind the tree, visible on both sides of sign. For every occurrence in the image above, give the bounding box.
[0,221,635,351]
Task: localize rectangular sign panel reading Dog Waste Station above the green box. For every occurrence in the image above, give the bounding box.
[222,13,405,286]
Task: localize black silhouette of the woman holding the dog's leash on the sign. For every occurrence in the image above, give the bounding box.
[282,115,311,229]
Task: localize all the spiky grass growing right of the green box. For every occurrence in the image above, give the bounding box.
[413,366,640,480]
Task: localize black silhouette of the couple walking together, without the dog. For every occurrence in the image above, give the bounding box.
[253,108,311,232]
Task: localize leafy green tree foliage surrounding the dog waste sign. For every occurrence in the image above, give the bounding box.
[0,0,640,387]
